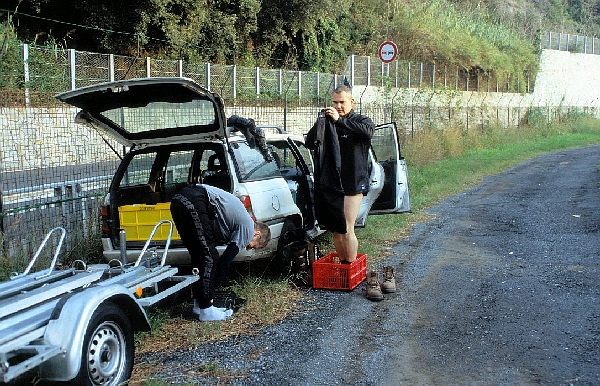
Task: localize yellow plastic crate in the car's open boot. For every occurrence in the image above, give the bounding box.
[119,202,181,241]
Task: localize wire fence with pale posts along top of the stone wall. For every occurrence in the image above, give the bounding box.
[0,41,531,104]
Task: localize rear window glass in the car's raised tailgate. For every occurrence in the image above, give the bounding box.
[102,99,216,133]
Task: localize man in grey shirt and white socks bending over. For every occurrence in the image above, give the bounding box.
[171,184,271,321]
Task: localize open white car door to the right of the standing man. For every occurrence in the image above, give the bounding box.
[355,123,410,228]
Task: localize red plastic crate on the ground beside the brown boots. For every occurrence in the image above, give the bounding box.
[312,252,367,291]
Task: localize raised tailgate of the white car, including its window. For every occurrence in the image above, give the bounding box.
[56,78,226,147]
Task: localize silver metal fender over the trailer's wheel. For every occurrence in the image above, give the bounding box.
[40,284,150,381]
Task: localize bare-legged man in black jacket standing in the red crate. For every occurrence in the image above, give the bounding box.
[306,85,375,263]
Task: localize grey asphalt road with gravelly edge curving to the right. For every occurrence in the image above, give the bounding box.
[139,146,600,385]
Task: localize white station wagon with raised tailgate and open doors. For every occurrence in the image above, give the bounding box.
[56,78,410,265]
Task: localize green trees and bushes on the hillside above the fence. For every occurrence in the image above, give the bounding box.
[0,0,600,80]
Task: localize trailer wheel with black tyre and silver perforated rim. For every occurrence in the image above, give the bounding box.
[72,302,134,385]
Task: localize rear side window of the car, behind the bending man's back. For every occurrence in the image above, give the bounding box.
[231,142,281,182]
